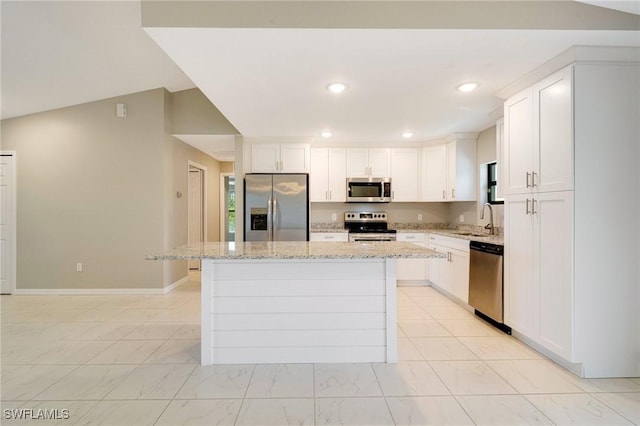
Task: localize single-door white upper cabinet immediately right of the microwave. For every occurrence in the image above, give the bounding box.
[391,148,419,201]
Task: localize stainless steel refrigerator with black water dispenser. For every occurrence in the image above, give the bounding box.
[244,174,309,241]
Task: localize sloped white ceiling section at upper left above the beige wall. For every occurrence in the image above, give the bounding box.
[0,0,194,119]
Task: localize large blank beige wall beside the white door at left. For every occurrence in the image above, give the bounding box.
[2,89,164,289]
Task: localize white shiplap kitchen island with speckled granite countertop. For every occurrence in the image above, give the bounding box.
[147,241,442,365]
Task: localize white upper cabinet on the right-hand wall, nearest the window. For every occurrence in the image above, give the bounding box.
[422,134,476,201]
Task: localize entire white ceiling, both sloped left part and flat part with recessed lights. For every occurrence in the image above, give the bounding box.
[1,1,640,159]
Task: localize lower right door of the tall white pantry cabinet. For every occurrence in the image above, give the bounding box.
[533,191,573,360]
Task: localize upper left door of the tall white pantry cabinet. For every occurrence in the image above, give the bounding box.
[502,89,534,195]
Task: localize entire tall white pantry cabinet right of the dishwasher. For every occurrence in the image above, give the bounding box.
[502,57,640,377]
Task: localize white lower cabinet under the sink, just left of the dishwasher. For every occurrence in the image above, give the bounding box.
[427,234,469,303]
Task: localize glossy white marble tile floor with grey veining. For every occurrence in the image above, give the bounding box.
[0,274,640,426]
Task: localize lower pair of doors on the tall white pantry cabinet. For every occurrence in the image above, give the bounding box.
[504,191,573,360]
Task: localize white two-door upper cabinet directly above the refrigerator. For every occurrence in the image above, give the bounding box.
[251,143,311,173]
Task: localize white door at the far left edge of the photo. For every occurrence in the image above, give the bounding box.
[0,153,16,294]
